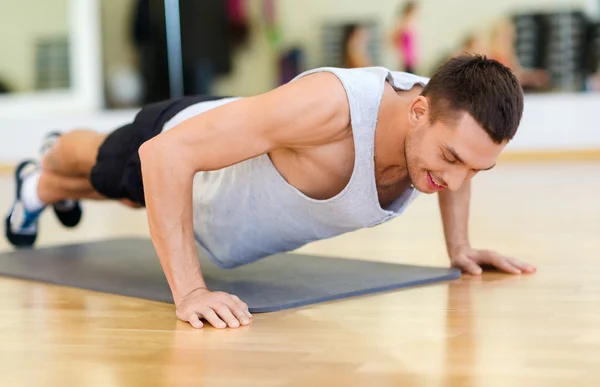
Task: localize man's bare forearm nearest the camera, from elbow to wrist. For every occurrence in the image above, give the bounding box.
[140,140,206,303]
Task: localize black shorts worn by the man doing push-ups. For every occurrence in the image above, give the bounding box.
[90,96,224,206]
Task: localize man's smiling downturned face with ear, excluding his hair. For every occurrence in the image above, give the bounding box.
[405,97,506,193]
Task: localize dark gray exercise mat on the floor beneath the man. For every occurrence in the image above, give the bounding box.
[0,238,460,313]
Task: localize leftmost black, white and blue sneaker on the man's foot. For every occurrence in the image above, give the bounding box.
[4,160,44,247]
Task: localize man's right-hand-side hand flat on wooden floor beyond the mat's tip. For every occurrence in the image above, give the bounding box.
[450,246,536,275]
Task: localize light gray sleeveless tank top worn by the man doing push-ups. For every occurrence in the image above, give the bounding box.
[163,67,428,268]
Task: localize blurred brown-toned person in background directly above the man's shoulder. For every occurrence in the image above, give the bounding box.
[342,24,373,68]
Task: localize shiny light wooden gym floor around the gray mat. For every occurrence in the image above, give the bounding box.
[0,163,600,387]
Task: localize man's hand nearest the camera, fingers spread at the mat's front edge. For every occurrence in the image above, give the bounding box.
[177,288,252,329]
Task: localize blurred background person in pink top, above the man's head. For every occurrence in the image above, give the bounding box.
[392,1,418,74]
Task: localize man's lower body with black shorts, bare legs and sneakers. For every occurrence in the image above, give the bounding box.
[5,96,209,246]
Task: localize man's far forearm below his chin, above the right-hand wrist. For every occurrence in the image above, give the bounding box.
[439,180,471,254]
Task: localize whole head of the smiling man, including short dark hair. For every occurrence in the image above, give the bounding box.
[403,54,524,193]
